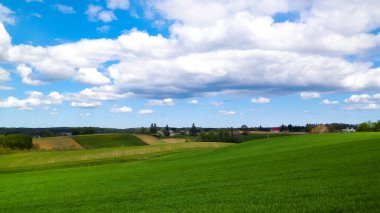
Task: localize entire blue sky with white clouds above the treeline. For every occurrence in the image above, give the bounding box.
[0,0,380,128]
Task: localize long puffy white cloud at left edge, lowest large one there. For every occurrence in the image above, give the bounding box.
[0,91,63,109]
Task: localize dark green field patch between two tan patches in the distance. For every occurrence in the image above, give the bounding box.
[73,134,146,149]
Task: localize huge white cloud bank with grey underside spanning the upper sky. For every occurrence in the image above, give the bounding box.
[0,0,380,99]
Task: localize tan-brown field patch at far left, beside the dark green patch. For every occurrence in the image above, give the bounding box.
[33,137,83,150]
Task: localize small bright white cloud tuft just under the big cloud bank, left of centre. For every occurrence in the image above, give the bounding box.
[73,68,111,85]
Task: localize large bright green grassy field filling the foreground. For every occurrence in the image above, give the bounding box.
[0,133,380,212]
